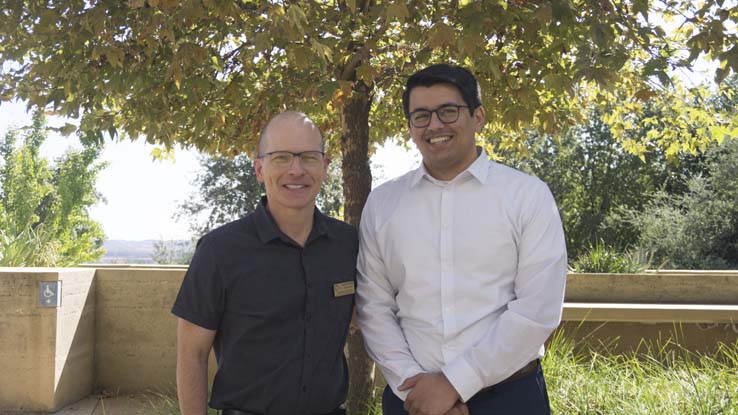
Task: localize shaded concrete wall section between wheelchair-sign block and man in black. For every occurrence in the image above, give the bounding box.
[95,267,216,393]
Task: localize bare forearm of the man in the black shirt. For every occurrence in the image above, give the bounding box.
[177,355,208,415]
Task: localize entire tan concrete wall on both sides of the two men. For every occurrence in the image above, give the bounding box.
[0,265,738,412]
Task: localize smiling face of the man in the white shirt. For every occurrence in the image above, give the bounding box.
[408,83,484,180]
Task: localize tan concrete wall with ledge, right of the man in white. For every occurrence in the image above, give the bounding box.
[559,271,738,353]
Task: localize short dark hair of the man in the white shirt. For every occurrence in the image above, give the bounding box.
[402,63,482,118]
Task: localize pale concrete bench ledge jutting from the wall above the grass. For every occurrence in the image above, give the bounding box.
[562,303,738,324]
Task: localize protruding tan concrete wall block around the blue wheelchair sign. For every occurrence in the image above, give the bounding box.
[0,268,95,411]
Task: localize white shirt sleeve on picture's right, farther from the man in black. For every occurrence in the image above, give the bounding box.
[442,182,567,401]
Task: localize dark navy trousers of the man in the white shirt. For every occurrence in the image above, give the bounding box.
[382,368,551,415]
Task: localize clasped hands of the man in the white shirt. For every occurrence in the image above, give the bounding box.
[398,373,459,415]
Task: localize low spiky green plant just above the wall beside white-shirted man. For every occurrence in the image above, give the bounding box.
[571,241,648,274]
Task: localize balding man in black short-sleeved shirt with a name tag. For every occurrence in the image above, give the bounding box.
[172,111,358,415]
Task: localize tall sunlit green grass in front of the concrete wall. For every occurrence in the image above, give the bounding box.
[152,330,738,415]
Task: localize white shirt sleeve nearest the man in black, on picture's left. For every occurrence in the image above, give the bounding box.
[356,197,425,400]
